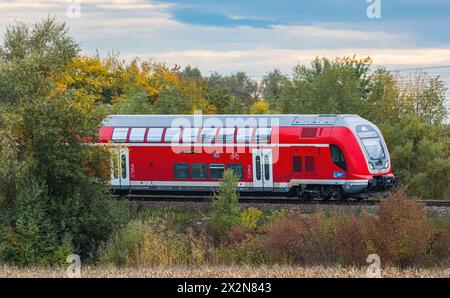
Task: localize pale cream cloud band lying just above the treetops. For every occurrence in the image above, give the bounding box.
[122,48,450,76]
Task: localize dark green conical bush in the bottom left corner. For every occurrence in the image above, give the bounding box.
[0,177,73,266]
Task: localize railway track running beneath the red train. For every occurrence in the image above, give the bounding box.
[114,194,450,207]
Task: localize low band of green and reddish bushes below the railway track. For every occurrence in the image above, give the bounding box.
[100,171,450,268]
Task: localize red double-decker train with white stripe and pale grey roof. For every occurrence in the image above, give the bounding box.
[97,115,394,199]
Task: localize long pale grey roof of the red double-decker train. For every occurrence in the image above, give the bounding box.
[103,114,366,127]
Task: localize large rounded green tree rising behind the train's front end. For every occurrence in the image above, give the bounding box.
[280,56,372,114]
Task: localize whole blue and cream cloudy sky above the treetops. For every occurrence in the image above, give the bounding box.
[0,0,450,112]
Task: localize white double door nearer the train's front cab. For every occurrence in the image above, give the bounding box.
[252,149,273,191]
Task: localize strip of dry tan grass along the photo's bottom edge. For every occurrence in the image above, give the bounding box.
[0,266,450,278]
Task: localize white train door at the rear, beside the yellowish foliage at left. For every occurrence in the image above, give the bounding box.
[111,148,130,189]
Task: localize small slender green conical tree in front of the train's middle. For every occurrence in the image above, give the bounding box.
[211,170,240,237]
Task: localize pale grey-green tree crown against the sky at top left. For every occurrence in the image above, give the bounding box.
[0,18,79,104]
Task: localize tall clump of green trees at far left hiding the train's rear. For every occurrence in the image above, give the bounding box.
[0,19,126,265]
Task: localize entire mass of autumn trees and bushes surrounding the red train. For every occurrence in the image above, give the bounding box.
[0,18,450,266]
